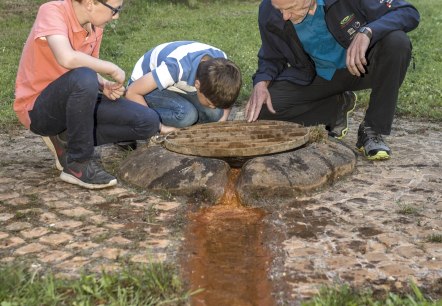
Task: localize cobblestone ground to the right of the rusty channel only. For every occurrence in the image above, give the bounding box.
[266,113,442,301]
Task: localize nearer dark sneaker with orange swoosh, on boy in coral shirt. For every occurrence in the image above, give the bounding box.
[60,158,117,189]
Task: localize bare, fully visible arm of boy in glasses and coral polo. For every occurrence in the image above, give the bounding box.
[46,35,126,87]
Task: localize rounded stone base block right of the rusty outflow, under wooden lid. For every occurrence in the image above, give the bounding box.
[236,141,356,206]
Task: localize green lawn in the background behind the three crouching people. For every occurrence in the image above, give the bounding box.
[0,0,442,128]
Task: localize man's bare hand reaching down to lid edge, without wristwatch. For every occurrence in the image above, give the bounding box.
[245,81,276,122]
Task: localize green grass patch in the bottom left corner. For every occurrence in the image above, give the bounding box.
[0,263,189,306]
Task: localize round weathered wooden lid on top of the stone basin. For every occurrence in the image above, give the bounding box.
[163,120,309,157]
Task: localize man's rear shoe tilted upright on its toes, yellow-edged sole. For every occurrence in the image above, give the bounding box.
[328,91,358,139]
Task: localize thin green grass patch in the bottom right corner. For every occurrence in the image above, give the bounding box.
[301,283,442,306]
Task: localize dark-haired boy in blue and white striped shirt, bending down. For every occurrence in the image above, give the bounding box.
[126,41,242,128]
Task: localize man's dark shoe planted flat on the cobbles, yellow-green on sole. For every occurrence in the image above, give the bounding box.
[356,124,391,160]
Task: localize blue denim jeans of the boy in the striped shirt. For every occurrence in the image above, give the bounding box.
[144,89,224,128]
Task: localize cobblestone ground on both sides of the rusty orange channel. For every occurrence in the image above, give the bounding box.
[0,110,442,302]
